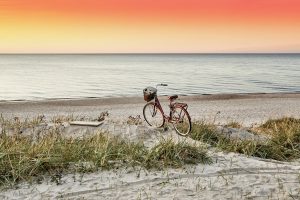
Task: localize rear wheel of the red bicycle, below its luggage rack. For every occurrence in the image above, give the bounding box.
[172,107,192,136]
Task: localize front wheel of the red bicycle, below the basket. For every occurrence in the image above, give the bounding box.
[143,102,165,128]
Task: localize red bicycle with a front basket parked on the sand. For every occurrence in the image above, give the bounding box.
[143,84,192,136]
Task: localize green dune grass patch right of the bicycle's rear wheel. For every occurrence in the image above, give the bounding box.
[191,118,300,161]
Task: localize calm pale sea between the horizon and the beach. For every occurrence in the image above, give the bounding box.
[0,54,300,100]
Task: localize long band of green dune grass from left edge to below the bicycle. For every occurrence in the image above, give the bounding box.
[0,115,210,186]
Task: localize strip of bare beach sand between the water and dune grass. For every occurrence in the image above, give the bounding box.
[0,93,300,126]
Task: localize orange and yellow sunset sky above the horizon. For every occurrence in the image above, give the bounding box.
[0,0,300,53]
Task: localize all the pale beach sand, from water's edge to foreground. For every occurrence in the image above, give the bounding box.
[0,94,300,199]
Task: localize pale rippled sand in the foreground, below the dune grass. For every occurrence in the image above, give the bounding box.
[0,152,300,200]
